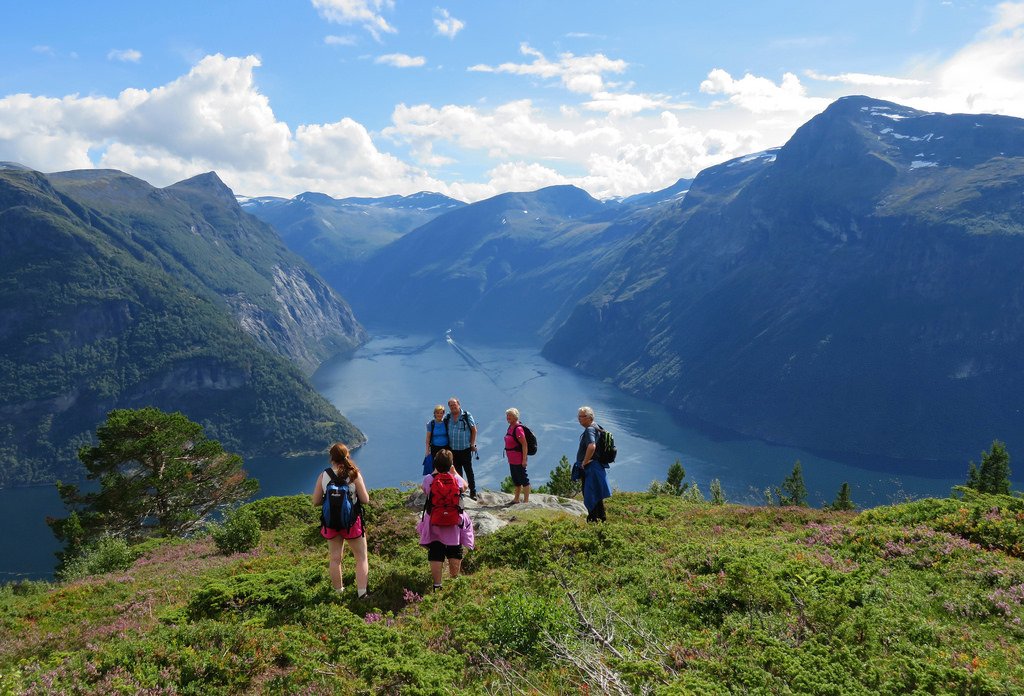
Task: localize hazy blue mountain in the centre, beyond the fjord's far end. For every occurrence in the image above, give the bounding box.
[347,186,655,344]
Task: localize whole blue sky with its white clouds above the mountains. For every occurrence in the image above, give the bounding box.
[0,0,1024,201]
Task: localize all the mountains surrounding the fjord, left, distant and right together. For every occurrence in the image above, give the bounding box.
[0,96,1024,480]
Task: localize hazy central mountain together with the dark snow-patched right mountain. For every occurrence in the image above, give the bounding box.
[274,96,1024,462]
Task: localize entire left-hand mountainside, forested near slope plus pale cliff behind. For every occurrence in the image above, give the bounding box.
[0,165,367,485]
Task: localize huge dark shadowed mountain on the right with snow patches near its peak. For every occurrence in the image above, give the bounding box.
[545,97,1024,460]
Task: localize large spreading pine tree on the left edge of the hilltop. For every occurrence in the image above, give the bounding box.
[47,407,259,559]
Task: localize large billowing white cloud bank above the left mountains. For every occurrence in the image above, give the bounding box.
[0,55,447,195]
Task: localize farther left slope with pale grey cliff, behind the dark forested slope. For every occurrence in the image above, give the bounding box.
[50,171,367,374]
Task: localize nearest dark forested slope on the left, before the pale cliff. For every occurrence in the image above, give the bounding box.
[0,170,364,485]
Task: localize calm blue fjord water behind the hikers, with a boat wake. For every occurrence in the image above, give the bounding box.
[0,334,974,580]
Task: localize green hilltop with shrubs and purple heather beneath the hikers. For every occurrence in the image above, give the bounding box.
[0,489,1024,694]
